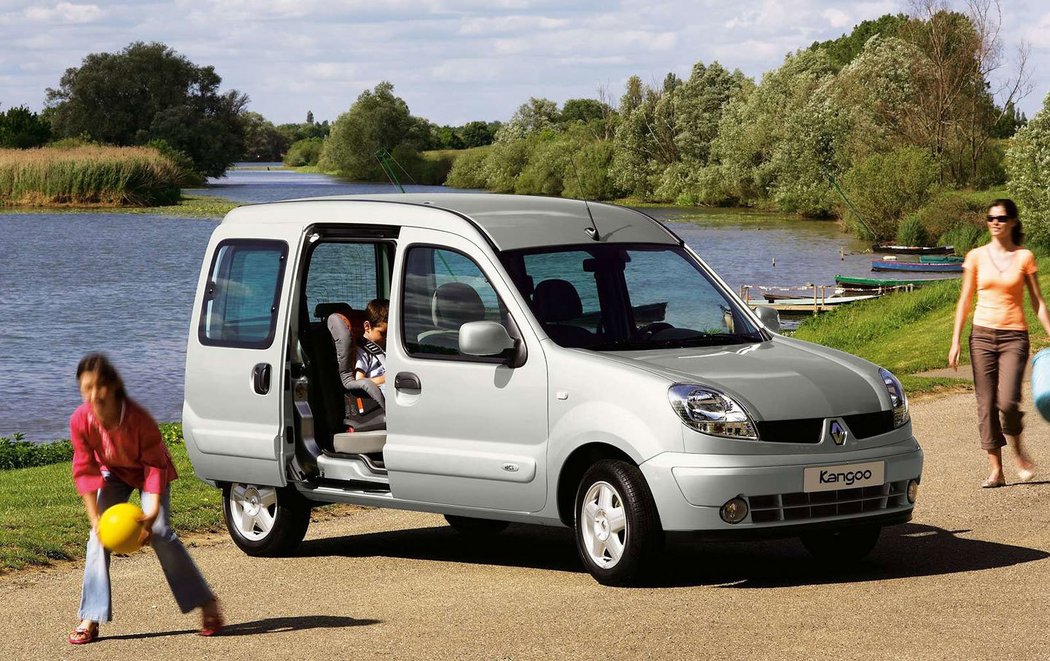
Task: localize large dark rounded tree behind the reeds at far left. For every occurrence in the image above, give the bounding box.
[46,42,248,176]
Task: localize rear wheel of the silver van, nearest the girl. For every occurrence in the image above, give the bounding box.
[223,482,310,557]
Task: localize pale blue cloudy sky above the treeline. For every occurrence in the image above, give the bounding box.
[0,0,1050,126]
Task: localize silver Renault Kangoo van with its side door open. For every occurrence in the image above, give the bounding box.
[183,193,923,584]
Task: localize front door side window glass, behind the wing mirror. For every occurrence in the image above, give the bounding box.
[401,246,506,360]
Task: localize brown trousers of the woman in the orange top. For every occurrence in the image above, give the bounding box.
[970,326,1028,450]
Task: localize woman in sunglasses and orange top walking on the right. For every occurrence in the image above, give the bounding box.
[948,199,1050,489]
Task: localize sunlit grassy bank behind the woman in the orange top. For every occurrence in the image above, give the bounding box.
[793,250,1050,393]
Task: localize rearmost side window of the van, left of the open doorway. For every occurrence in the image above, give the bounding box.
[197,240,288,348]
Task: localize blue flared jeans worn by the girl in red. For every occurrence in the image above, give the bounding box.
[80,474,214,622]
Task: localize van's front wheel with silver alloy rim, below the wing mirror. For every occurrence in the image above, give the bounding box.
[575,460,664,585]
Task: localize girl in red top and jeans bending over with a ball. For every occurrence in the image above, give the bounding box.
[69,354,223,645]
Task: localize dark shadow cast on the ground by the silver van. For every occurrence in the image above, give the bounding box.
[298,524,1050,588]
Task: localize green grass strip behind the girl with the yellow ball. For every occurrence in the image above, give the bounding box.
[0,425,224,575]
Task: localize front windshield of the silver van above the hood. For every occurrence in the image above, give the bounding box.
[501,243,765,350]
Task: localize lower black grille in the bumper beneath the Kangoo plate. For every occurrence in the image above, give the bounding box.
[748,479,908,524]
